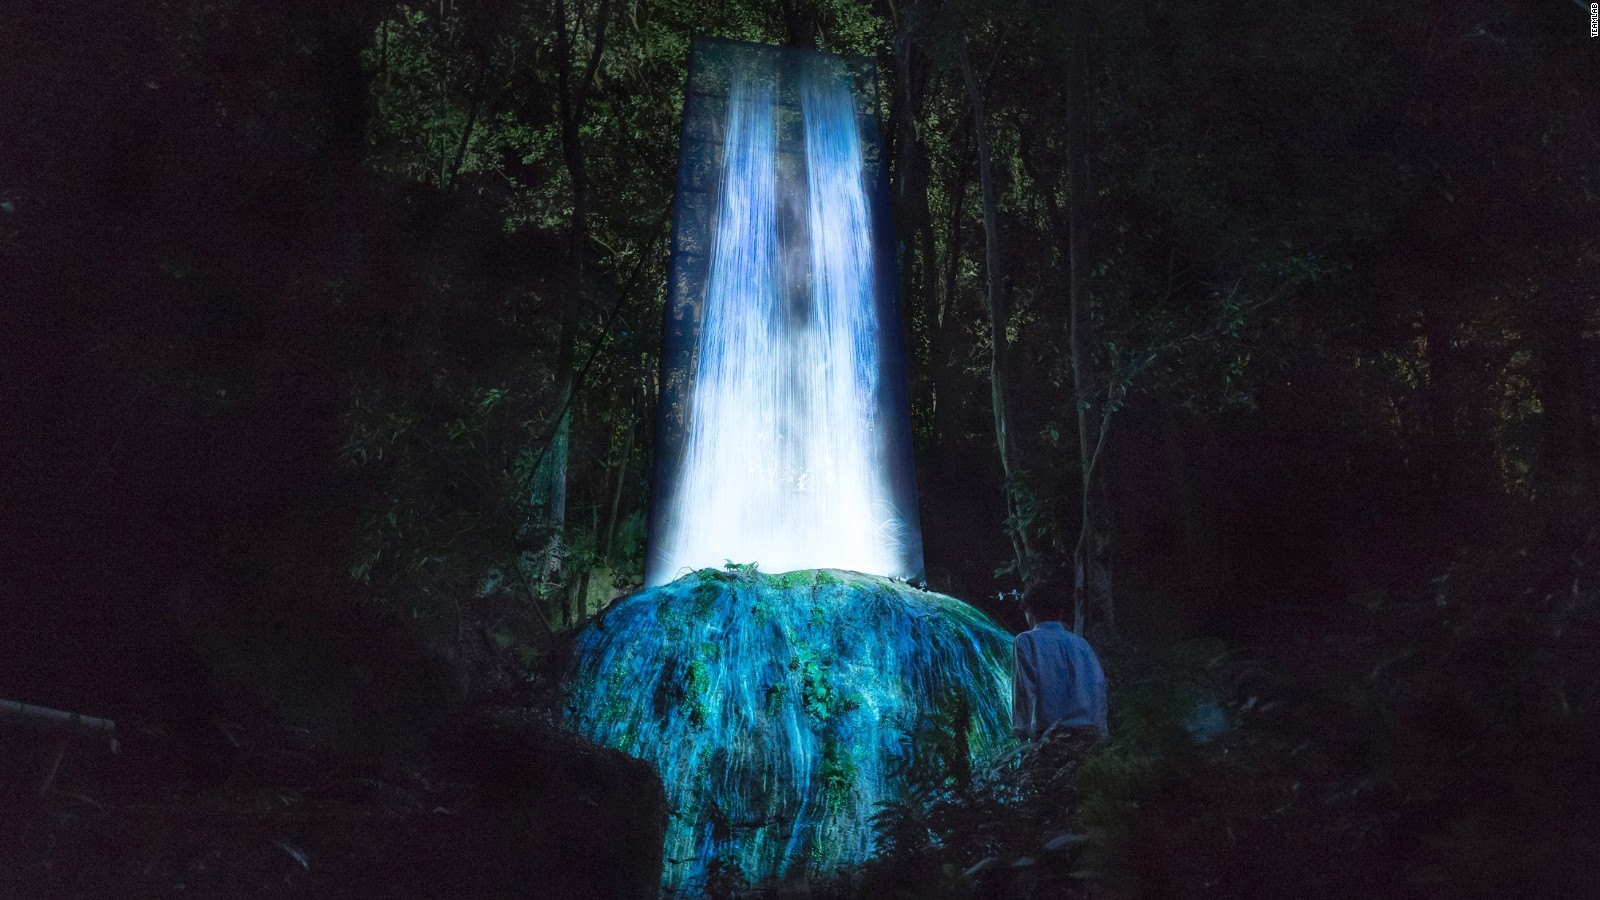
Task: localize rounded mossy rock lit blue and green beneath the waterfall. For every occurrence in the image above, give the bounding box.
[568,569,1011,890]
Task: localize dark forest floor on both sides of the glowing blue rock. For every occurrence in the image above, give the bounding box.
[0,538,1600,900]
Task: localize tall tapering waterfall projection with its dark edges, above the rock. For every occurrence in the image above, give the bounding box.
[646,43,922,585]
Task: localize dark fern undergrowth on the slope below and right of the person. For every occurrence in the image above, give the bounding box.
[830,534,1600,900]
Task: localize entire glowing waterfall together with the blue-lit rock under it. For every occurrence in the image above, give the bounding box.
[566,40,1011,895]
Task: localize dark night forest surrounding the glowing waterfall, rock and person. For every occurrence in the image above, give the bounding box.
[0,0,1600,900]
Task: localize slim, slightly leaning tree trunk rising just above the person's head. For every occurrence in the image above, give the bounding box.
[957,38,1035,580]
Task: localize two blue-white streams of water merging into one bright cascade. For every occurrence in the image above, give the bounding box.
[650,59,910,585]
